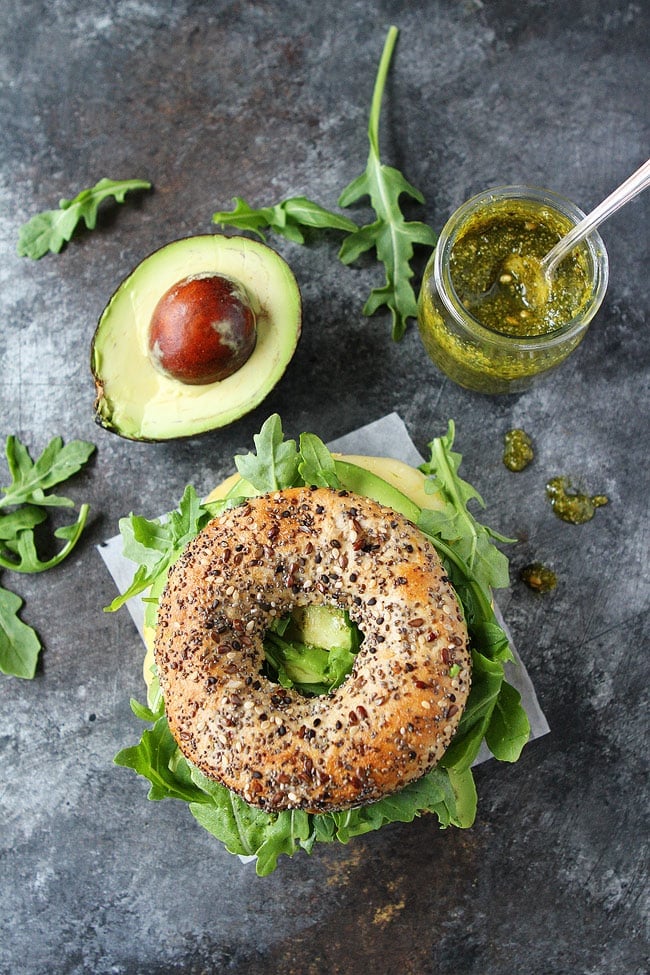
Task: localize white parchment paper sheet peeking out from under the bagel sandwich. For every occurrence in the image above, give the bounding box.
[98,413,549,764]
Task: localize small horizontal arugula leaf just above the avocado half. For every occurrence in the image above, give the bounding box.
[212,196,357,244]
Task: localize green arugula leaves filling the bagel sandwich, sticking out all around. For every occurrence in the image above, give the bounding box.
[110,415,530,875]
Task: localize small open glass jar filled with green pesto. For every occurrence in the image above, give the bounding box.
[417,186,608,394]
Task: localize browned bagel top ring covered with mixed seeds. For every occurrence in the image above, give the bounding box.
[154,488,470,812]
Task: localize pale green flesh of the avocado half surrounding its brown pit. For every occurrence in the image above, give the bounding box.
[91,234,302,441]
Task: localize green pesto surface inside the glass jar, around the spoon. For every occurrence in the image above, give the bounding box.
[450,200,591,337]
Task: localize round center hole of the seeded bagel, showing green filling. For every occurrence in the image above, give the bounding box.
[260,604,363,697]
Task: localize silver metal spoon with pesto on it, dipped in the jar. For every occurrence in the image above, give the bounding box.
[472,159,650,308]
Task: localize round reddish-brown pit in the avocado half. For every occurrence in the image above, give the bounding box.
[149,272,257,386]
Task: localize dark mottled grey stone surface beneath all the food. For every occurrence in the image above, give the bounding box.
[0,0,650,975]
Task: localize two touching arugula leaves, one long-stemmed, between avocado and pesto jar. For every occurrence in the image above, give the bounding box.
[212,27,436,340]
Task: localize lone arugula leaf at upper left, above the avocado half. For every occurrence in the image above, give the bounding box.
[17,178,151,260]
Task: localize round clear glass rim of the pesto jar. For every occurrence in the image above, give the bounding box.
[433,184,609,352]
